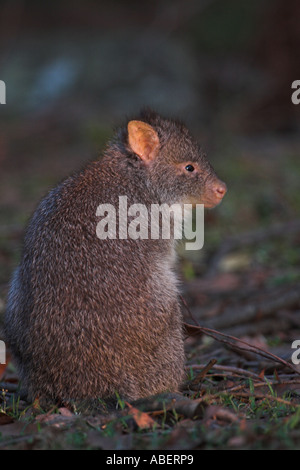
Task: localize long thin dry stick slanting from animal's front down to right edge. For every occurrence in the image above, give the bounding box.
[181,297,300,375]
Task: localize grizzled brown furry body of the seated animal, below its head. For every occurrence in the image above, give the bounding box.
[6,159,184,401]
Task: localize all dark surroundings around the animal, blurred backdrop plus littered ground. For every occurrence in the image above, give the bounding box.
[0,0,300,452]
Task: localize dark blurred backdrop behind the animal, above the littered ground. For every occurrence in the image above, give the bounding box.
[0,0,300,330]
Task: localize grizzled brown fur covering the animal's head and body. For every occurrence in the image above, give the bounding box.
[5,108,226,401]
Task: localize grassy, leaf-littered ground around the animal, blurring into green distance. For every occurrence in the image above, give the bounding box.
[0,119,300,450]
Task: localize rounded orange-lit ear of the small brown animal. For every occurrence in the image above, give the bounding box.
[128,121,159,163]
